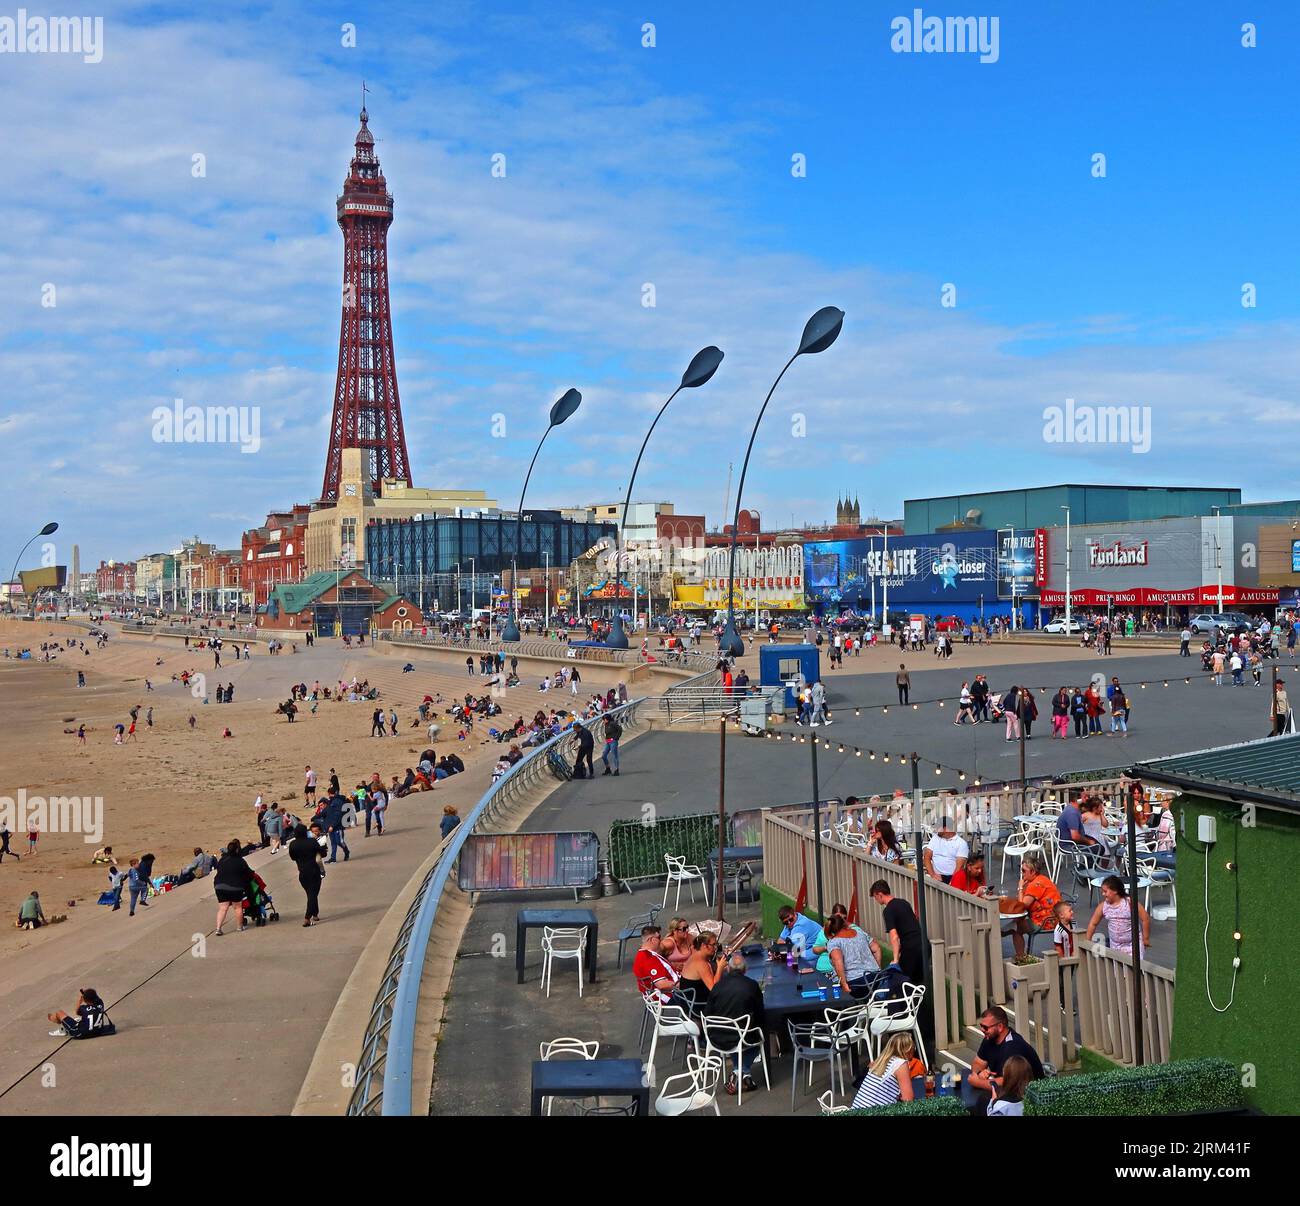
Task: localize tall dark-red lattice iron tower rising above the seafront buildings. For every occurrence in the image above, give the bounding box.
[321,105,413,502]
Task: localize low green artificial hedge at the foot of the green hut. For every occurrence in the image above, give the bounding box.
[1024,1059,1245,1118]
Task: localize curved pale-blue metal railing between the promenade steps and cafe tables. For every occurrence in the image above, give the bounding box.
[347,699,645,1118]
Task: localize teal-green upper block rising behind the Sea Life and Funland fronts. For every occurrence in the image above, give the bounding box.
[902,485,1242,535]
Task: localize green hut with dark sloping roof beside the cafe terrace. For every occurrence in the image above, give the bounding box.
[1138,738,1300,1115]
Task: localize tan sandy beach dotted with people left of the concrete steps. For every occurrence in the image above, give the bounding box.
[0,620,629,954]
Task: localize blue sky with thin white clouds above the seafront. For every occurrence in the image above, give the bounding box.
[0,0,1300,572]
